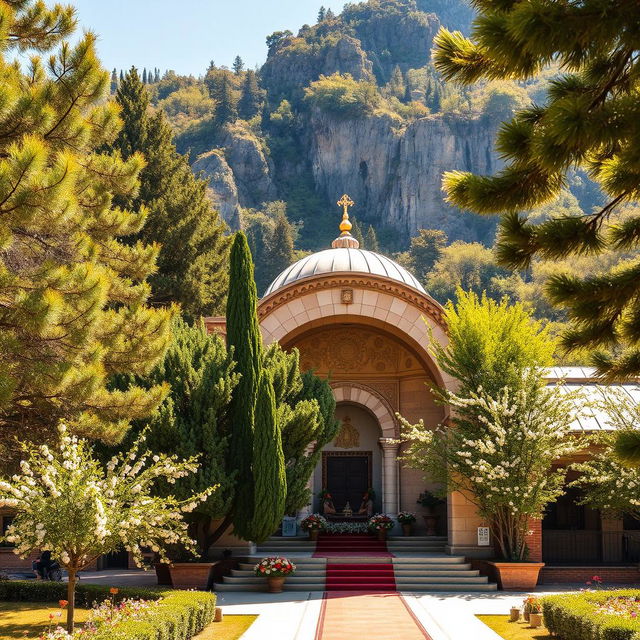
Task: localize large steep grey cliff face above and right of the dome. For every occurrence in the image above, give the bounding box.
[309,111,500,240]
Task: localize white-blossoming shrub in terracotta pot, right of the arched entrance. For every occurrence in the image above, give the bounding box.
[401,371,579,561]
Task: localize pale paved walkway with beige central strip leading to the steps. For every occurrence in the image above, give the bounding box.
[75,571,584,640]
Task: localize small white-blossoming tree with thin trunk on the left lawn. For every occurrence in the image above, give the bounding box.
[0,426,215,633]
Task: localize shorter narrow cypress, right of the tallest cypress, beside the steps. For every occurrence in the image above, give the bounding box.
[251,369,287,542]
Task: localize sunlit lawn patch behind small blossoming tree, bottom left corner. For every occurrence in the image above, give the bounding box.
[0,602,89,640]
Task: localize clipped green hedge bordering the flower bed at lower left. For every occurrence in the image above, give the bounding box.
[0,580,216,640]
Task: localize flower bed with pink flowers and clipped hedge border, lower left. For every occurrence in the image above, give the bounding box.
[0,580,216,640]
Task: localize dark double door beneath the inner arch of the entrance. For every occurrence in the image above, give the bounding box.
[322,451,371,512]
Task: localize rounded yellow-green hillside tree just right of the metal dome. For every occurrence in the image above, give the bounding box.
[426,241,509,303]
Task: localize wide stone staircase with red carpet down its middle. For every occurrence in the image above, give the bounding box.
[215,536,496,592]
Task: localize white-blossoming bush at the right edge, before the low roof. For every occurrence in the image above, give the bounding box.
[571,390,640,519]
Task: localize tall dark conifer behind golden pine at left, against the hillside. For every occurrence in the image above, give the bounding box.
[107,69,229,316]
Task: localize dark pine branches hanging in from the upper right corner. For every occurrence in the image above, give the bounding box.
[435,0,640,379]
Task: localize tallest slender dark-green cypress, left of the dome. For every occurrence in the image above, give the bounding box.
[226,231,262,540]
